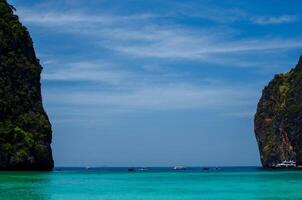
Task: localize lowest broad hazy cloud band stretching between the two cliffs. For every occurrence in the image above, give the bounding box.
[45,84,256,111]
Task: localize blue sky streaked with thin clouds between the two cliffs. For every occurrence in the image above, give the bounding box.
[10,0,302,166]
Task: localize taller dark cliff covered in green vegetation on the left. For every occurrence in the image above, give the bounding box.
[0,0,53,170]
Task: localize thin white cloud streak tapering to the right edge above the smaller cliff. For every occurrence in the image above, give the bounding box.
[113,35,302,59]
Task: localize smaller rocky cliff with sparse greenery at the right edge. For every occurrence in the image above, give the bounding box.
[255,56,302,167]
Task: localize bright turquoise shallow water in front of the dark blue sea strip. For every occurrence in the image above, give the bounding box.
[0,169,302,200]
